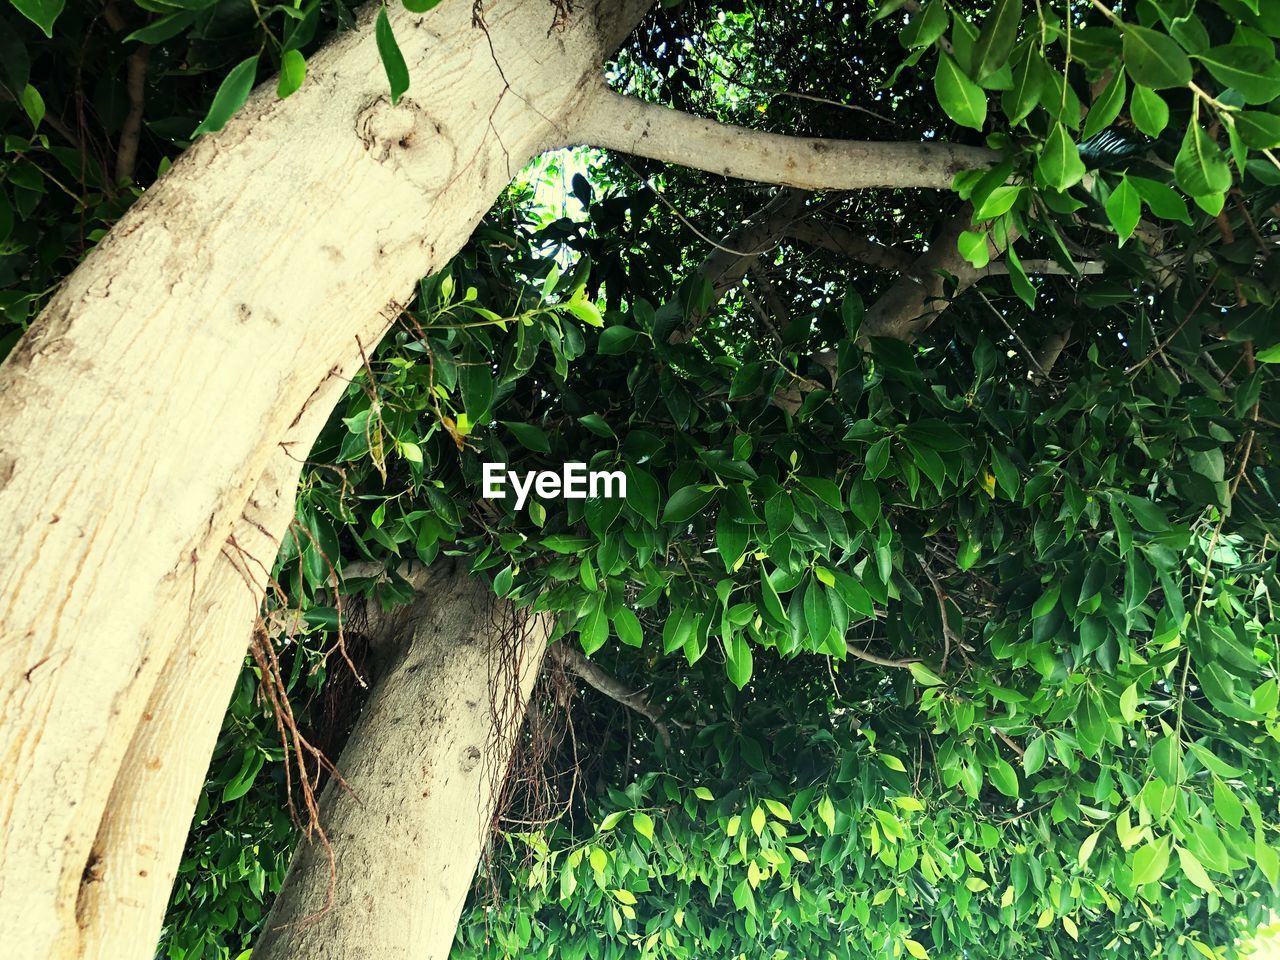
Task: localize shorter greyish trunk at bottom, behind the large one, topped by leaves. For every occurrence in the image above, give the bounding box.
[253,564,549,960]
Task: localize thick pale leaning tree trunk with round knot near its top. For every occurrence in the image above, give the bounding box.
[0,0,648,960]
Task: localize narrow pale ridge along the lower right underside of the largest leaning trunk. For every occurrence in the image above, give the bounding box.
[66,370,343,960]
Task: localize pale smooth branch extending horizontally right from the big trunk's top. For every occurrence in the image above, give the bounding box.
[570,84,998,189]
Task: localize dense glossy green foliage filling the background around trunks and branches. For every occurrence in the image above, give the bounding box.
[0,0,1280,960]
